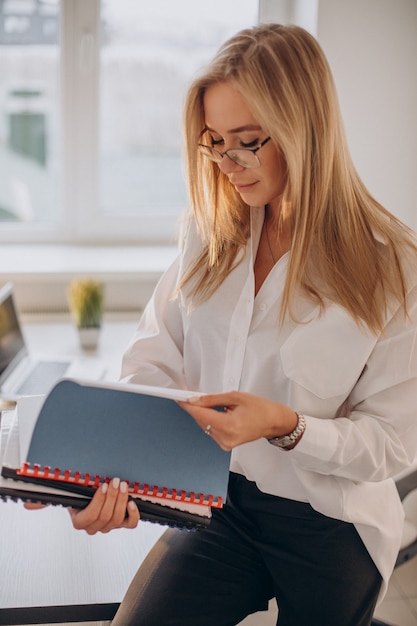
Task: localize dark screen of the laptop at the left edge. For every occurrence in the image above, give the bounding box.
[0,285,26,381]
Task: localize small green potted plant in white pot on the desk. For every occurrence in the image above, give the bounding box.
[68,278,104,348]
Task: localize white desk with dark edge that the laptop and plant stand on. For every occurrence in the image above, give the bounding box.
[0,320,164,625]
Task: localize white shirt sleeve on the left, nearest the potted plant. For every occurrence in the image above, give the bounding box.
[121,257,186,389]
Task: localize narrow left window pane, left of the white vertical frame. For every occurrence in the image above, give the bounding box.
[0,0,60,223]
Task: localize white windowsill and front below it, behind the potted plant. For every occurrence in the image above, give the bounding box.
[0,244,177,315]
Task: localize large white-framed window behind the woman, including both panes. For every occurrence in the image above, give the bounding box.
[0,0,258,242]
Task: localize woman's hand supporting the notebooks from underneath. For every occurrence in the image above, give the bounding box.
[69,478,140,535]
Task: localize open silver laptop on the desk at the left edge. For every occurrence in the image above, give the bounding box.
[0,283,104,400]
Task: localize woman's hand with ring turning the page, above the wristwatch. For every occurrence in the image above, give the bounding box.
[178,391,298,450]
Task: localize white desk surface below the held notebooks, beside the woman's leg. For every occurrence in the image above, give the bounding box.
[0,502,163,608]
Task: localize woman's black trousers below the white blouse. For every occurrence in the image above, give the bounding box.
[113,474,381,626]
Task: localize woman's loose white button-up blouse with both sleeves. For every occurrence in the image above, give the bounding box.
[122,208,417,599]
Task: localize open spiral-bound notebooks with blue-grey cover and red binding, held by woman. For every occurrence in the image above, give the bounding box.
[0,379,230,529]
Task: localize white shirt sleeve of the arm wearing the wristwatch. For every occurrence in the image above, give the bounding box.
[287,280,417,481]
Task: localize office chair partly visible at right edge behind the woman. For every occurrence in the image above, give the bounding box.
[372,470,417,626]
